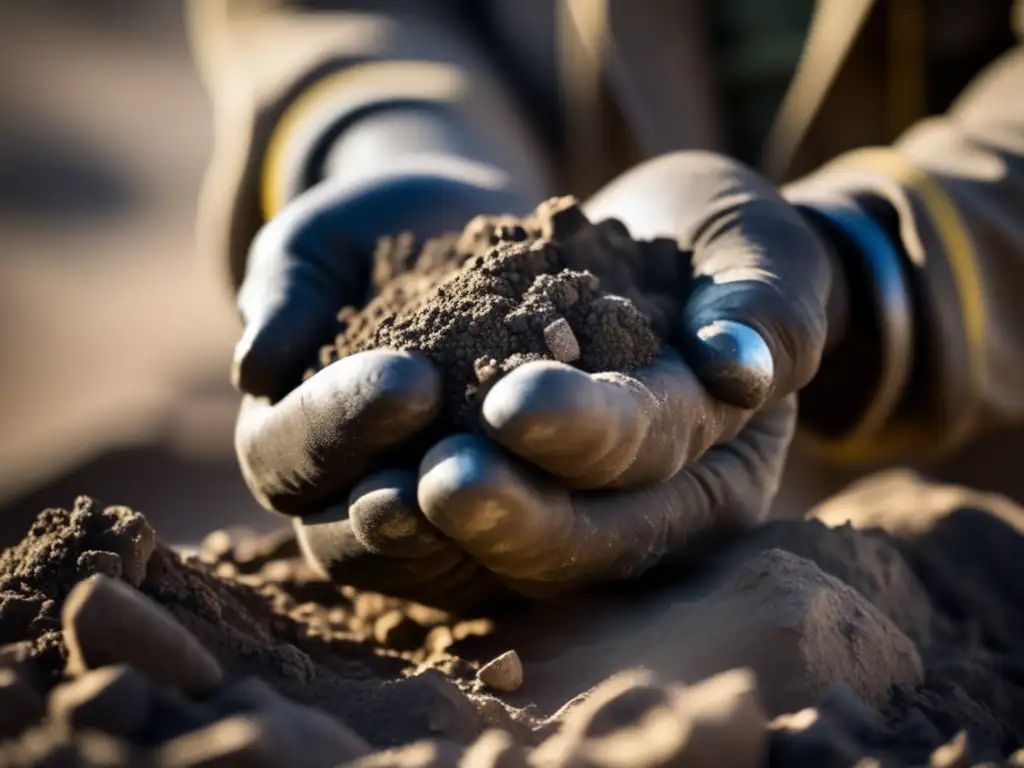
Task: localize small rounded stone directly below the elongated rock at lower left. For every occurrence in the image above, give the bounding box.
[48,666,151,736]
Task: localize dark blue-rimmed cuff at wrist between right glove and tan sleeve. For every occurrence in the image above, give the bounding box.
[778,190,914,458]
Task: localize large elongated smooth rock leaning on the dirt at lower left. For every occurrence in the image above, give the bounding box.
[61,574,223,695]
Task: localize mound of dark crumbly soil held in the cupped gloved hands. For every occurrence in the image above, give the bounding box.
[310,198,691,430]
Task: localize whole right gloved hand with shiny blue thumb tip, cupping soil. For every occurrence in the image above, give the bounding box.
[300,154,831,596]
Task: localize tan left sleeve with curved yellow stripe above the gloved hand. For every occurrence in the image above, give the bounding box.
[187,0,549,289]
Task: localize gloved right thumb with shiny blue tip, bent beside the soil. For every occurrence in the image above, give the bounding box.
[681,158,830,409]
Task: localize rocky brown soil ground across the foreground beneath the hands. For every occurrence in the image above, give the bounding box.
[0,475,1024,766]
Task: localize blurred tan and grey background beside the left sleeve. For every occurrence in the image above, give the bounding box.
[0,0,281,546]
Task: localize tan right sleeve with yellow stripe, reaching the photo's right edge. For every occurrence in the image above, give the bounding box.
[793,46,1024,463]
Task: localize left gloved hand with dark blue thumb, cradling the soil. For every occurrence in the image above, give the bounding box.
[232,164,527,610]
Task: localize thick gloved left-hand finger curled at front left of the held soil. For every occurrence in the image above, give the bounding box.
[234,349,441,515]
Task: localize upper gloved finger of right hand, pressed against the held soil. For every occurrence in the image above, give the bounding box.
[481,348,751,489]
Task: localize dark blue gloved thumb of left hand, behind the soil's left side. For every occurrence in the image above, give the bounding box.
[232,171,536,399]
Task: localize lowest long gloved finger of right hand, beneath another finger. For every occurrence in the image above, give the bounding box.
[418,397,796,594]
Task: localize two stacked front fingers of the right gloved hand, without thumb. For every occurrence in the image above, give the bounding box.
[418,350,796,596]
